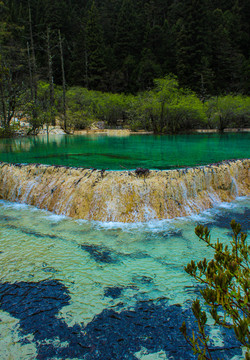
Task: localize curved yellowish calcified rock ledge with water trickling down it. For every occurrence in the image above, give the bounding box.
[0,159,250,222]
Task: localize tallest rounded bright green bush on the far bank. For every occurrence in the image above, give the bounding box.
[130,76,206,134]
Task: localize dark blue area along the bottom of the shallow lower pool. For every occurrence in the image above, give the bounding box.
[0,280,241,360]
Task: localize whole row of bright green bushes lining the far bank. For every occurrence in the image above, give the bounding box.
[0,76,250,136]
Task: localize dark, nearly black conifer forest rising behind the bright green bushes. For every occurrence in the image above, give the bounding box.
[1,0,250,98]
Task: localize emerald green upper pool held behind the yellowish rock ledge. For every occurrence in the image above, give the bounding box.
[0,133,250,170]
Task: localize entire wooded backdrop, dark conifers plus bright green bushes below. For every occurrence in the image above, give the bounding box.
[0,0,250,133]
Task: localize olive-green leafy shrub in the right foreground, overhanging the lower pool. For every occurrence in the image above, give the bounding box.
[181,220,250,360]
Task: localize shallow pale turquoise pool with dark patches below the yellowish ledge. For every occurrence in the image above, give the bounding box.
[0,198,250,360]
